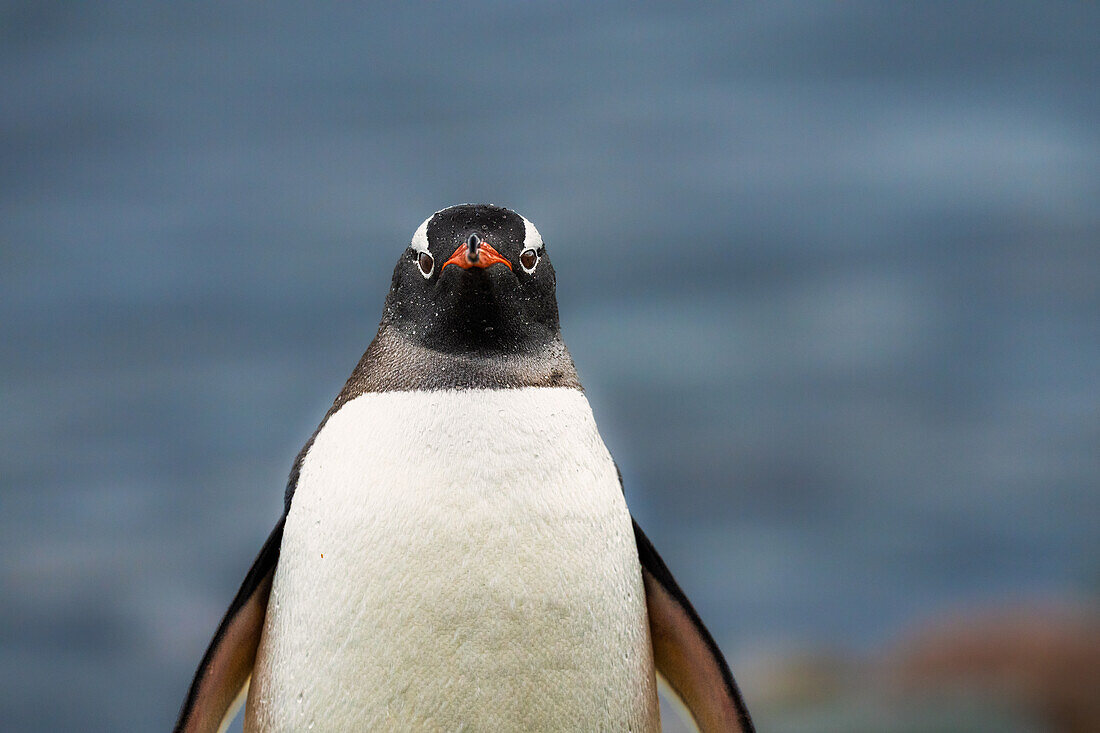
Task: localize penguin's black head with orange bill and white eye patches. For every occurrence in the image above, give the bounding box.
[382,204,560,353]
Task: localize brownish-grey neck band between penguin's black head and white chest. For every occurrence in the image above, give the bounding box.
[333,324,582,408]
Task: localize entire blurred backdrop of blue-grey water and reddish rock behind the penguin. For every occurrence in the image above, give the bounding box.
[0,2,1100,731]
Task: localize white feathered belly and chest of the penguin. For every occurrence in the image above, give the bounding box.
[245,387,660,731]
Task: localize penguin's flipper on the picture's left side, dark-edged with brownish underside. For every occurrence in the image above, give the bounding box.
[173,515,286,733]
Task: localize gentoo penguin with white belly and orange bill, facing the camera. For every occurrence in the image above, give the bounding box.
[176,205,752,733]
